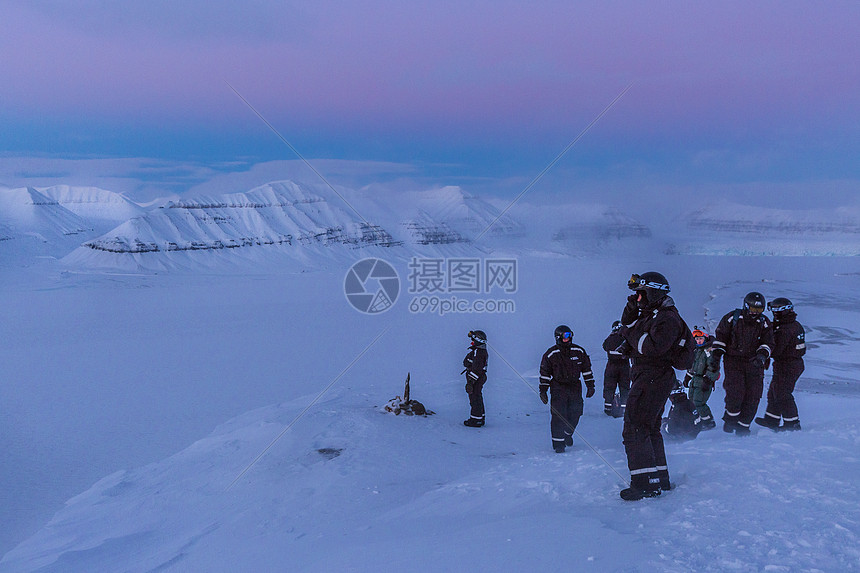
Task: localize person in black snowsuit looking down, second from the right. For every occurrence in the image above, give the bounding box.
[710,292,773,436]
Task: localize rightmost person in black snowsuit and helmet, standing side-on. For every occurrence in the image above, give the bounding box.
[755,297,806,430]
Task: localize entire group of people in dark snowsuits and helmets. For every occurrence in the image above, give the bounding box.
[463,272,806,500]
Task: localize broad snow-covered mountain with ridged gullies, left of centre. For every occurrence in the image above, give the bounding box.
[66,181,402,269]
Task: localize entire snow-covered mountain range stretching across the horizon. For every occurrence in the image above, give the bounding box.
[0,181,860,270]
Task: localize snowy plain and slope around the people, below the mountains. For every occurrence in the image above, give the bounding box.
[0,182,860,571]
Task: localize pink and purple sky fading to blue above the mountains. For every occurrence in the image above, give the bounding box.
[0,0,860,207]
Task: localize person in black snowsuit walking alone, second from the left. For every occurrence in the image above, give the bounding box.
[540,324,594,454]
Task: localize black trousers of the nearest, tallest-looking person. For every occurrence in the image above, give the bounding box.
[621,366,676,489]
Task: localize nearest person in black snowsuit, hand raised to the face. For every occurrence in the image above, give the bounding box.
[619,272,686,501]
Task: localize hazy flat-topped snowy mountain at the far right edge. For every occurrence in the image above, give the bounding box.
[667,202,860,256]
